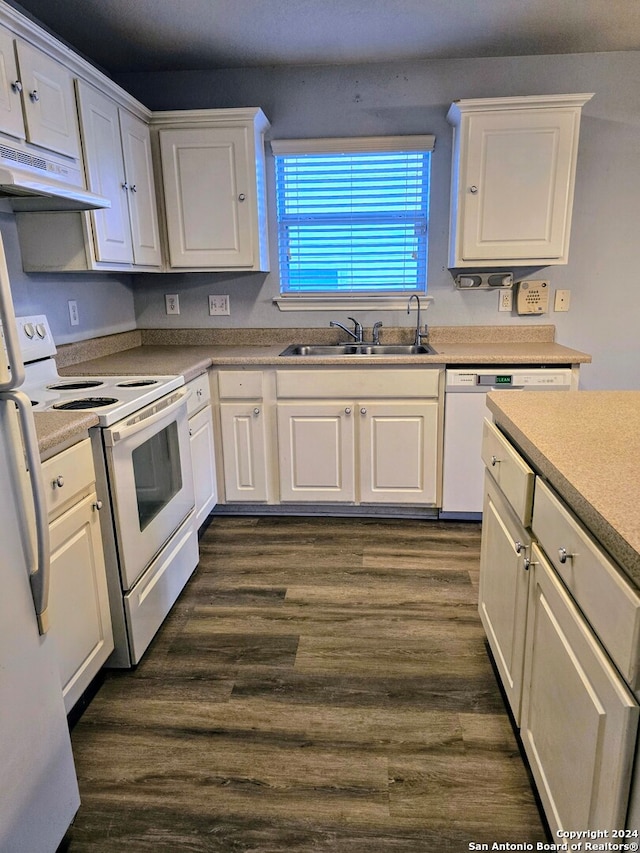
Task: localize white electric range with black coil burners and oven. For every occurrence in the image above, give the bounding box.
[17,315,198,667]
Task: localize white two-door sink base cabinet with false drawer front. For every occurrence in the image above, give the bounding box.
[276,368,441,505]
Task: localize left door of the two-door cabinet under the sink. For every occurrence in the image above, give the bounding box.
[278,401,355,502]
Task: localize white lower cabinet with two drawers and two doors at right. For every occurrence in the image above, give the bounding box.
[479,424,640,837]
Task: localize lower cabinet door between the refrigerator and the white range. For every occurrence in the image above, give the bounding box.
[49,492,113,713]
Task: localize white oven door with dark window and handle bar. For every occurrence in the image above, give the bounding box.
[103,389,195,591]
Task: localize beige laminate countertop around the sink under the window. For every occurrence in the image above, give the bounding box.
[60,341,591,382]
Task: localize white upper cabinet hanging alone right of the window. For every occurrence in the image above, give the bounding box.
[447,94,592,268]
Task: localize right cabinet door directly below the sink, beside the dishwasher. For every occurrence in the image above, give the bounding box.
[356,400,438,504]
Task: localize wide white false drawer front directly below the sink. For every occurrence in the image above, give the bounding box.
[276,366,440,400]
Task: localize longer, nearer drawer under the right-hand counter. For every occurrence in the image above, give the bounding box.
[533,477,640,690]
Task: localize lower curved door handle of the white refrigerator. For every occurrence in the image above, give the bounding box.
[2,391,51,634]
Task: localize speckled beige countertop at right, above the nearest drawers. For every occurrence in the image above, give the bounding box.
[487,391,640,587]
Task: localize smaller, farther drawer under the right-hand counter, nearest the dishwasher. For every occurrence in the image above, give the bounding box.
[482,420,535,527]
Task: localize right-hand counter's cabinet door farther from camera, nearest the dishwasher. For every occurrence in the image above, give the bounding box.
[478,473,531,725]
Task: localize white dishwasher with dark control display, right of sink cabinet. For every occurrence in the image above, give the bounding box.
[440,365,577,519]
